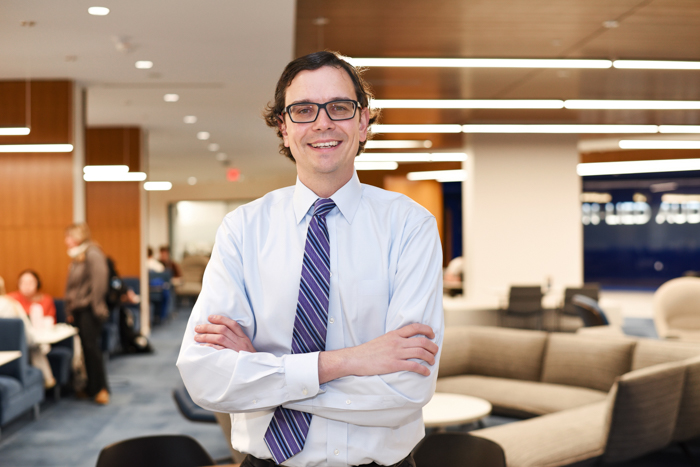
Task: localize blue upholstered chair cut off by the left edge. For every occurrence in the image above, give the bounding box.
[0,318,44,438]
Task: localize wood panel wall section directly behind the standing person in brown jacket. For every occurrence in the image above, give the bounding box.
[85,127,141,277]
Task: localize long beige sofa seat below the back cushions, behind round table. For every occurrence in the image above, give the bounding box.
[437,375,607,418]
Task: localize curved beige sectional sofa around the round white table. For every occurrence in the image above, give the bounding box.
[437,326,700,467]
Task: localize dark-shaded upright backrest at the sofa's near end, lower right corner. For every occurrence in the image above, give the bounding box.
[603,361,686,463]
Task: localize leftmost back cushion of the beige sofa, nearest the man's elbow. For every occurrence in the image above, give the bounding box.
[438,326,547,381]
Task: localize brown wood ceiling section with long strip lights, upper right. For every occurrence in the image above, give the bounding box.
[295,0,700,148]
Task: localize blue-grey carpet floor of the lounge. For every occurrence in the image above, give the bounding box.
[0,310,700,467]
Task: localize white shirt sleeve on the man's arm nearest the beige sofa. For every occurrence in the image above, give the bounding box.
[285,217,444,427]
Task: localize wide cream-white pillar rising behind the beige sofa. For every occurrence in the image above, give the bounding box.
[463,134,583,306]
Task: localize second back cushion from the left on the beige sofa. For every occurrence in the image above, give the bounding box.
[542,333,636,392]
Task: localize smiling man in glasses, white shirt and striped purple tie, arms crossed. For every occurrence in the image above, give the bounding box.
[178,52,443,467]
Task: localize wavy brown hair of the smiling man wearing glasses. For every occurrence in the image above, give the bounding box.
[263,50,379,160]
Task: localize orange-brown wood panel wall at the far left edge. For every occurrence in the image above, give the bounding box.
[0,80,73,297]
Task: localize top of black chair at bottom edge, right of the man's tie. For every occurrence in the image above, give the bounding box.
[413,432,506,467]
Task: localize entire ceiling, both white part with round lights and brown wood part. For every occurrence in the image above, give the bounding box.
[0,0,700,184]
